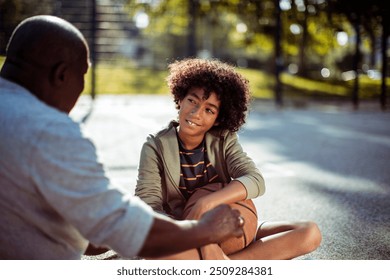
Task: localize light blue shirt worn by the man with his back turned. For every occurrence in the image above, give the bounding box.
[0,78,153,259]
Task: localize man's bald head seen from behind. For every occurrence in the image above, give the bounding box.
[0,15,89,113]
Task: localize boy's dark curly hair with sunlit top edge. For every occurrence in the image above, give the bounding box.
[167,58,251,132]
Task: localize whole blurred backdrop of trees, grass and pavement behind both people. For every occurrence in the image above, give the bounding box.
[0,0,390,260]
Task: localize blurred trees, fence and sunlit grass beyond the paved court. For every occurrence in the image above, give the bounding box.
[0,0,390,110]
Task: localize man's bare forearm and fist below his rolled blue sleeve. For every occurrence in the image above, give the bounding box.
[139,204,243,258]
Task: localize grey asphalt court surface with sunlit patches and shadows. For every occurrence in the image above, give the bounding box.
[71,95,390,260]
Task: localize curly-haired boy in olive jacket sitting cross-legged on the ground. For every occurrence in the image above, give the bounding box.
[136,59,321,259]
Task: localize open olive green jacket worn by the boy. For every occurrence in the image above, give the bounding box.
[135,121,265,218]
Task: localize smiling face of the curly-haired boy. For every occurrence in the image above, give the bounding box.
[179,88,221,139]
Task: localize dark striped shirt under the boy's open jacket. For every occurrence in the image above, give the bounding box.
[177,137,218,199]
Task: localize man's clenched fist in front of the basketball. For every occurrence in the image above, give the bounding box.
[199,204,244,243]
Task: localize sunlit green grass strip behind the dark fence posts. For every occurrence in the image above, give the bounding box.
[0,56,390,99]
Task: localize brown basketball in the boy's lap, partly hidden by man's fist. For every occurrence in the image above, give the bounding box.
[183,184,257,255]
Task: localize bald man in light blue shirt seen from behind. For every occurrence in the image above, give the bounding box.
[0,16,242,259]
